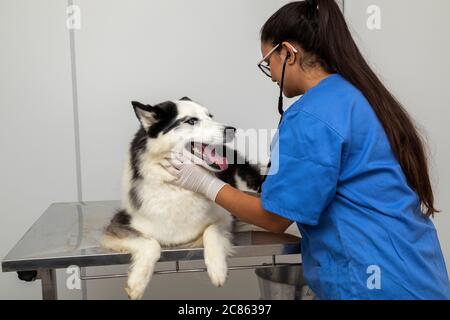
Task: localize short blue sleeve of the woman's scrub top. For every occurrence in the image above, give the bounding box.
[261,110,344,225]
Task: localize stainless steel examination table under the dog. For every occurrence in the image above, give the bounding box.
[2,201,300,299]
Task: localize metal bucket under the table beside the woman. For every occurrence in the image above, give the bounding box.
[255,265,314,300]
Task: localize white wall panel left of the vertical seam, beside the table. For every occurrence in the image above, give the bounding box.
[0,0,76,299]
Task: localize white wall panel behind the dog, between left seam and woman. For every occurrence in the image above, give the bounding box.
[71,0,287,200]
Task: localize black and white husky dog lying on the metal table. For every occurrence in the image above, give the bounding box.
[102,97,262,299]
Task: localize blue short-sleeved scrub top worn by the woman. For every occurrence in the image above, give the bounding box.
[261,74,450,299]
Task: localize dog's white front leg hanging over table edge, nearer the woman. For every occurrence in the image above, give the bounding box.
[203,224,232,287]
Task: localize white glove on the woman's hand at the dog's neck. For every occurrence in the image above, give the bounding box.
[163,153,227,201]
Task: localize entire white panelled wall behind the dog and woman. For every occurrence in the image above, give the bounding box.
[0,0,450,299]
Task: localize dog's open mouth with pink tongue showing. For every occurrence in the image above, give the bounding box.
[186,141,228,171]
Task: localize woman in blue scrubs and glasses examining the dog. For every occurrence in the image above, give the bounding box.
[169,0,450,299]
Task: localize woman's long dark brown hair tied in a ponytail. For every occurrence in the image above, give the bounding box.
[261,0,439,217]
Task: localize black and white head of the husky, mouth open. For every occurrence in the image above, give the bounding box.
[132,97,236,171]
